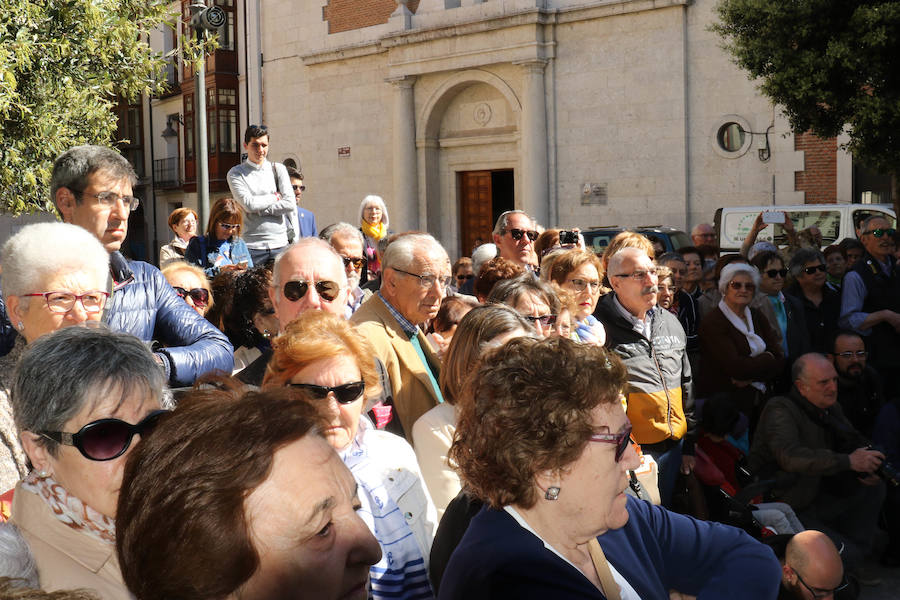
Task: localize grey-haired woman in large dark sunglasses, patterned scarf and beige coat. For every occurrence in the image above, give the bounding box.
[11,327,166,599]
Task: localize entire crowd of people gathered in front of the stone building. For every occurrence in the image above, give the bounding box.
[0,125,900,600]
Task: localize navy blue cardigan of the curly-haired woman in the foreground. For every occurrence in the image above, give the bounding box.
[439,497,781,600]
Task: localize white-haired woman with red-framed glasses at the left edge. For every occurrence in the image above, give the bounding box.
[0,223,109,493]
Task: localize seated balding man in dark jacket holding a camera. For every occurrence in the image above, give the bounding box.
[749,353,885,581]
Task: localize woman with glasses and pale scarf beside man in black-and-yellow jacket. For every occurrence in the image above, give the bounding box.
[550,250,606,346]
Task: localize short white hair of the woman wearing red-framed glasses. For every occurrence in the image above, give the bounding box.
[0,223,109,300]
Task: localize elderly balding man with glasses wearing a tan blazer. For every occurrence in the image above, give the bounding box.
[350,234,450,434]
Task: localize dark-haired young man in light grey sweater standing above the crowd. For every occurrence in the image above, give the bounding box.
[227,125,299,265]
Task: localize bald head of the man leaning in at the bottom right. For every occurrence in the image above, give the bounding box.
[783,529,844,598]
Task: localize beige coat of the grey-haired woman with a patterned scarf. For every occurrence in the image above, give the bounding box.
[10,483,132,600]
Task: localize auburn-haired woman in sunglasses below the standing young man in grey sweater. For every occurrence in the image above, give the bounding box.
[184,198,253,279]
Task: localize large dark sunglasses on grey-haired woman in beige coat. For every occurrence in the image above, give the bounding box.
[40,410,169,461]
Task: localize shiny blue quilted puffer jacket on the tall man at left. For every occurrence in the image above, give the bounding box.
[103,252,234,387]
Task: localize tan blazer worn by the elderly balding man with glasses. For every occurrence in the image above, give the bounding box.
[350,294,440,440]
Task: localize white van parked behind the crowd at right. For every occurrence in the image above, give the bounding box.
[715,204,897,253]
